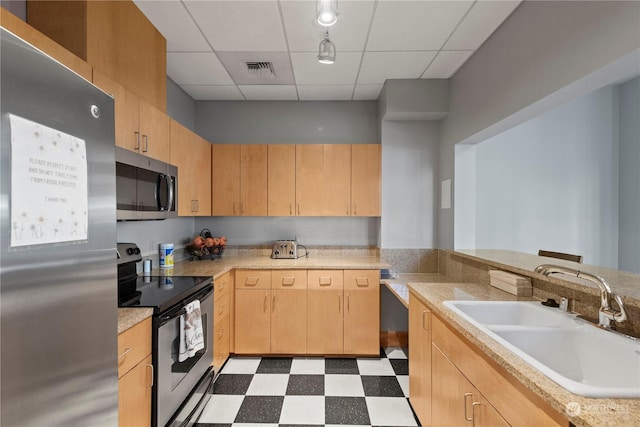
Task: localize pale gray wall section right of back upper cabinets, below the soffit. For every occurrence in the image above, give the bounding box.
[380,120,439,249]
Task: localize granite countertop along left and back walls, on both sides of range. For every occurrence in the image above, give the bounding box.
[118,256,390,333]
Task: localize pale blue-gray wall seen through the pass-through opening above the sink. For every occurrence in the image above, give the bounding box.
[468,86,616,269]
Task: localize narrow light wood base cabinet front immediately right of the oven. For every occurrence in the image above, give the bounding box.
[213,273,233,369]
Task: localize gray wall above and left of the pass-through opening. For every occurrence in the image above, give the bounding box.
[439,1,640,248]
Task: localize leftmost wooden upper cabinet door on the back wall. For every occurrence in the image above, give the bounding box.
[211,144,240,216]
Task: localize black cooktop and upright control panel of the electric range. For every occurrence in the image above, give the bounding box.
[118,243,212,314]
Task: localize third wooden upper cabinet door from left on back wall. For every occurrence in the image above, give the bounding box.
[267,144,296,216]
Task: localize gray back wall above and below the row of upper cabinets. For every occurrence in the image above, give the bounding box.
[195,101,380,246]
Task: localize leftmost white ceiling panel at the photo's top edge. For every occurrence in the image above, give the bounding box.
[135,0,211,52]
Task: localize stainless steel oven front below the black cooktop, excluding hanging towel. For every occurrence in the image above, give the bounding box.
[152,286,213,426]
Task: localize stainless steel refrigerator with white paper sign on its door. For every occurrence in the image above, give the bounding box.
[0,29,118,427]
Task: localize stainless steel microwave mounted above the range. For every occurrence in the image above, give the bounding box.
[116,147,178,221]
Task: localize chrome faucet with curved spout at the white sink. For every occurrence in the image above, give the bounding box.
[535,264,627,329]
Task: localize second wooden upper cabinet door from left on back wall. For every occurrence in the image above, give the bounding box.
[240,144,268,216]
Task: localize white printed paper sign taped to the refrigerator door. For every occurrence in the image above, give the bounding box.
[9,114,89,247]
